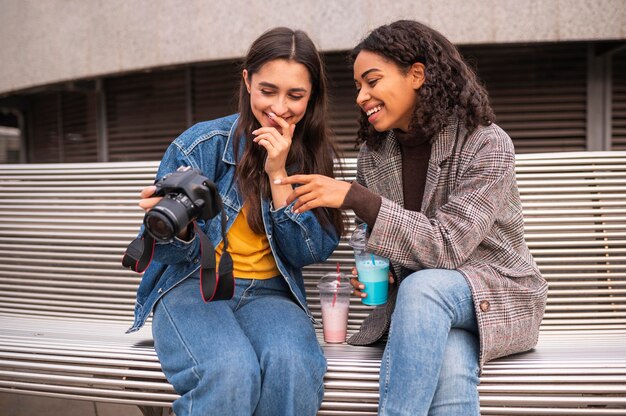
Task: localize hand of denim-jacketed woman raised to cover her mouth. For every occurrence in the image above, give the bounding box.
[252,114,296,181]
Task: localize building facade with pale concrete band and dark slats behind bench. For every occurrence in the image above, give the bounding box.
[0,0,626,163]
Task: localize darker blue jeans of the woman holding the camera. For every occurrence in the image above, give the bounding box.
[152,277,326,416]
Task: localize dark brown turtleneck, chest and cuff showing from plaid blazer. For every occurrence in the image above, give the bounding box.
[341,130,431,228]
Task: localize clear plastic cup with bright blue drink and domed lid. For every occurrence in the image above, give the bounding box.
[350,224,389,306]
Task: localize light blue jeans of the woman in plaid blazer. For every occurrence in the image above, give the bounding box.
[379,269,480,416]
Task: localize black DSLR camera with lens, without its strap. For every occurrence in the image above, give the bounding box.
[143,167,221,241]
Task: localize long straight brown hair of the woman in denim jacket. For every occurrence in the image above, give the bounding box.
[235,27,344,235]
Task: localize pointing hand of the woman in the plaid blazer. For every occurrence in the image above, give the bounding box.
[274,175,351,213]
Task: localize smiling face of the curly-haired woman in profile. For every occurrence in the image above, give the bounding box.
[354,50,424,132]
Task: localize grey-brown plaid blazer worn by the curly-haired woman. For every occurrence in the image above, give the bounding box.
[349,117,547,368]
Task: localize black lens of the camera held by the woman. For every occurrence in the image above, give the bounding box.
[144,194,194,241]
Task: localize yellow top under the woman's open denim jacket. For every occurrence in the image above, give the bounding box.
[215,204,280,279]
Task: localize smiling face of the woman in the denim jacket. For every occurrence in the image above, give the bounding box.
[243,59,312,131]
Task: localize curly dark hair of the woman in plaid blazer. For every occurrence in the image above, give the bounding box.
[350,20,495,149]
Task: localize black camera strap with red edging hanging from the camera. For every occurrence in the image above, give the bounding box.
[122,207,235,302]
